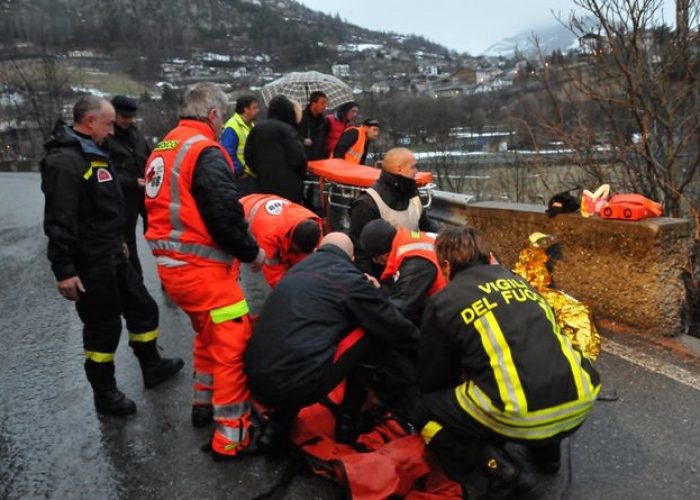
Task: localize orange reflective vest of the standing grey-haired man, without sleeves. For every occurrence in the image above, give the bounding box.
[145,120,233,265]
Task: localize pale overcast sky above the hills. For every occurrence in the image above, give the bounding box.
[299,0,674,55]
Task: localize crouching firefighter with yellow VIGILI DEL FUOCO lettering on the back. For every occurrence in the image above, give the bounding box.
[415,227,600,493]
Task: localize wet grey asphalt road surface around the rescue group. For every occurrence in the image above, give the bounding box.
[0,173,700,499]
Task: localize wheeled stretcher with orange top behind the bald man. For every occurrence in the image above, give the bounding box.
[308,158,435,229]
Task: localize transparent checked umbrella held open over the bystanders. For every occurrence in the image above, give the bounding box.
[262,71,352,109]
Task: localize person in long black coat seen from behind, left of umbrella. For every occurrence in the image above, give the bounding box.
[243,95,306,204]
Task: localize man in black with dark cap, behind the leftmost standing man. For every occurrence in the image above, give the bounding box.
[107,95,151,276]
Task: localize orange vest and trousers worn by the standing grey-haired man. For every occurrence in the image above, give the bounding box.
[145,120,251,455]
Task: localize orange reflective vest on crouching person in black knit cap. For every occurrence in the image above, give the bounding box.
[381,228,447,297]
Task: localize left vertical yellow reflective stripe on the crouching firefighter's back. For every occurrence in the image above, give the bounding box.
[474,311,527,413]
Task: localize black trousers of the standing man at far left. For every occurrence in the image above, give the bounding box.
[75,253,158,360]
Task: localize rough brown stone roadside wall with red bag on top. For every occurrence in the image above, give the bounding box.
[430,192,692,335]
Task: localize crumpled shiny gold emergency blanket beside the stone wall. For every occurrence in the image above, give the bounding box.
[513,233,600,360]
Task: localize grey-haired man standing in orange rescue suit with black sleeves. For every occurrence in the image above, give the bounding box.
[145,82,265,459]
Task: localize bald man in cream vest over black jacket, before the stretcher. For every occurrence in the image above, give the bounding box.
[350,148,438,275]
